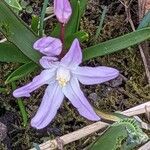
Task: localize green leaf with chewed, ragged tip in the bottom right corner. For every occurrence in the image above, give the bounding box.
[89,118,149,150]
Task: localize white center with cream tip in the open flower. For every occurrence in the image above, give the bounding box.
[56,67,70,87]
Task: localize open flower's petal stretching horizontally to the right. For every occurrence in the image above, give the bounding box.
[73,66,119,85]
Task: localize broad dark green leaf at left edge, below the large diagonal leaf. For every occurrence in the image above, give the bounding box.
[0,42,30,63]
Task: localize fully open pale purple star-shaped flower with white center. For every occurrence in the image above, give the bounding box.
[13,39,119,129]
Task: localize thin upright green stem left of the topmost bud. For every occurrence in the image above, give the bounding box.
[39,0,49,36]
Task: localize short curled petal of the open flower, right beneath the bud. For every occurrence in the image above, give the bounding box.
[40,56,58,69]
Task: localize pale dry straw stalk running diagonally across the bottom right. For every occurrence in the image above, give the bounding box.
[31,102,150,150]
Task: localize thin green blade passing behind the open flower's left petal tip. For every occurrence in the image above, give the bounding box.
[12,82,28,127]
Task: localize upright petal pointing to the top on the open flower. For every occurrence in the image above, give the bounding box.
[61,39,82,69]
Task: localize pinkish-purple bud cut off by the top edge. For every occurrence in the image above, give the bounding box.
[54,0,72,24]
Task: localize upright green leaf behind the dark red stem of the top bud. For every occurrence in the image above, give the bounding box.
[52,0,87,38]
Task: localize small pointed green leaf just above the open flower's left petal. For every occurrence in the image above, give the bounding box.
[5,62,38,84]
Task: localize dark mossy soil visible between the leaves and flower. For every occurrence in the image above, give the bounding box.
[0,0,150,150]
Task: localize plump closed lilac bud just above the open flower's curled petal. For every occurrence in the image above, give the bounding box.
[33,36,62,56]
